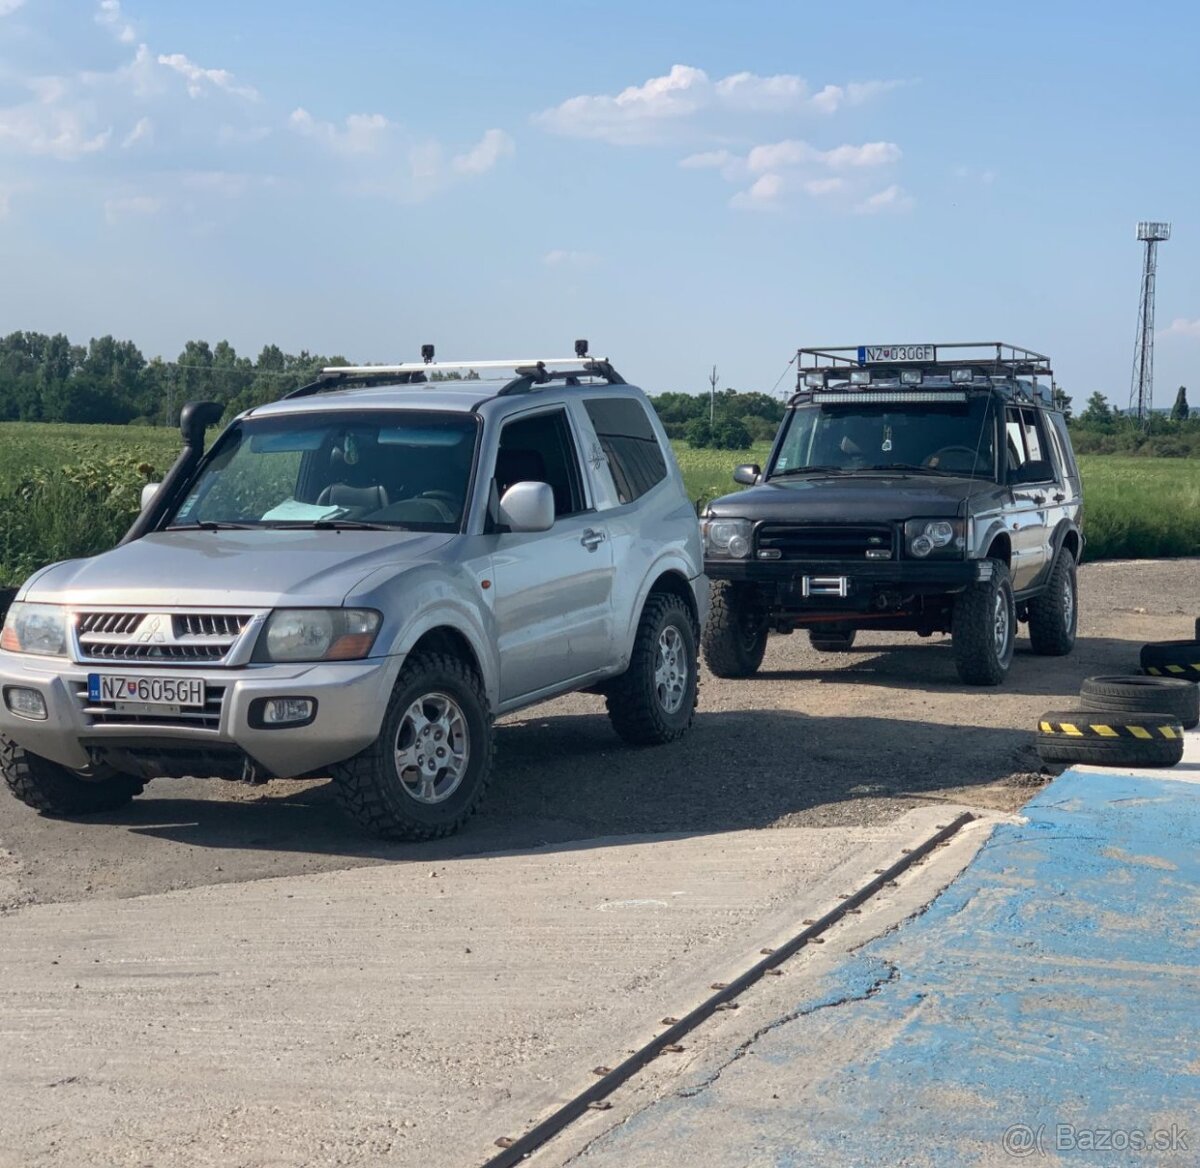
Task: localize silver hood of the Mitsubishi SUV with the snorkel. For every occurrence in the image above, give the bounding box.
[23,531,456,609]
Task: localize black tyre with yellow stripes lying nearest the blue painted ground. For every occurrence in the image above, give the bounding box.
[1037,709,1183,768]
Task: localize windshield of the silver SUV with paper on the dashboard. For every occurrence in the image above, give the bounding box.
[168,409,478,532]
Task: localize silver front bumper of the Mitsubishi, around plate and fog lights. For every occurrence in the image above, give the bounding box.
[0,652,400,777]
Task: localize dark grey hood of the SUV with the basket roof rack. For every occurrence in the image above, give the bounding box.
[708,474,1001,523]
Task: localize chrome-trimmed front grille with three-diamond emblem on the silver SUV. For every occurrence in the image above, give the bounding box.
[76,611,252,665]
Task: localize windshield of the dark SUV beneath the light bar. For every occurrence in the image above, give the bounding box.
[768,395,996,479]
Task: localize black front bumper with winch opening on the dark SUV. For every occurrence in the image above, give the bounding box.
[704,559,991,612]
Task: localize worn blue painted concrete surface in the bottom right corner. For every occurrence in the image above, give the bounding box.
[583,772,1200,1168]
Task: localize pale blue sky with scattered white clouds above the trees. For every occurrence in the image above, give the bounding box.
[0,0,1200,405]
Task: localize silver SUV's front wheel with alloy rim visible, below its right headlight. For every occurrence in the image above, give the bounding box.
[332,653,494,840]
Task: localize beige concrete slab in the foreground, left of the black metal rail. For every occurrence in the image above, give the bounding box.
[0,805,988,1168]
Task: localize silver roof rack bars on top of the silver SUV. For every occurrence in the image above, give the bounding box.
[279,341,625,397]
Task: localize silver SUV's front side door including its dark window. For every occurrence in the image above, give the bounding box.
[492,406,614,703]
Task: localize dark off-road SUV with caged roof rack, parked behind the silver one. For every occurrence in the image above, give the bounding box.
[702,342,1084,685]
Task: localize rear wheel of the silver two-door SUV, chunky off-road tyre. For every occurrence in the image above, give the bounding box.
[606,593,698,747]
